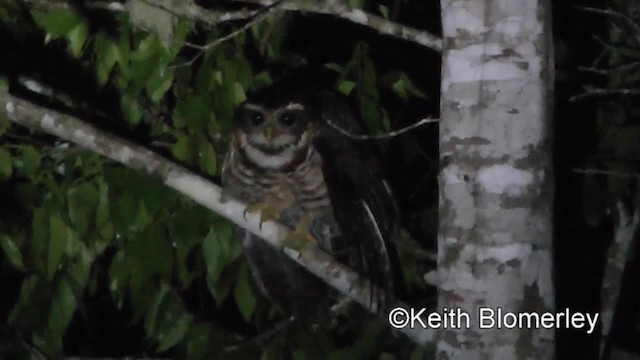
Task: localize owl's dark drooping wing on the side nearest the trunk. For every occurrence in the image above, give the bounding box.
[314,93,399,311]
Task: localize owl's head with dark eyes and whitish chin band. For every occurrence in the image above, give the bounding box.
[233,100,314,169]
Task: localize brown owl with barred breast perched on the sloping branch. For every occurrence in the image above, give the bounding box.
[222,87,398,317]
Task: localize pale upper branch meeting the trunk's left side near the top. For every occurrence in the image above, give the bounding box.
[228,0,442,51]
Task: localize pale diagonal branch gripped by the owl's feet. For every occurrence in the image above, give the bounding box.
[0,91,435,346]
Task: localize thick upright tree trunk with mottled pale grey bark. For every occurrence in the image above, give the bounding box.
[437,0,554,360]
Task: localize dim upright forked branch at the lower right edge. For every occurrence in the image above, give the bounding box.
[600,201,640,358]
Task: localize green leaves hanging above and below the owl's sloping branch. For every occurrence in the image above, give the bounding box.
[0,1,425,359]
